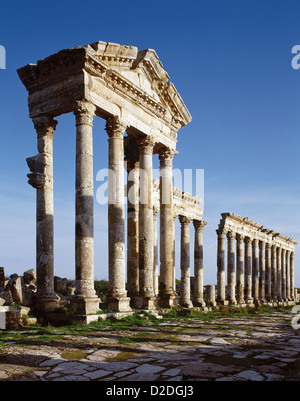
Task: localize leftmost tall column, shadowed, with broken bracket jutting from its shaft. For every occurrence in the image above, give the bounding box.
[27,116,58,312]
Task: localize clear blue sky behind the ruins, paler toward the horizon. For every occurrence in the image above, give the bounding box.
[0,0,300,287]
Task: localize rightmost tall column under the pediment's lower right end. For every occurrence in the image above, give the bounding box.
[159,148,176,307]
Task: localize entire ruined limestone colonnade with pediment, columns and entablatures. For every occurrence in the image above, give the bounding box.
[12,42,296,322]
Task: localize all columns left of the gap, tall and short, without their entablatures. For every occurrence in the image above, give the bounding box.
[27,101,206,314]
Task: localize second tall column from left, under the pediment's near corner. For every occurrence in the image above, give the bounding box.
[74,101,100,314]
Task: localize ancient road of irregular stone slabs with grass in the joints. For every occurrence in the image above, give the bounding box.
[0,312,300,381]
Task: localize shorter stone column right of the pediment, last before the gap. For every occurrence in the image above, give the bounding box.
[193,220,207,306]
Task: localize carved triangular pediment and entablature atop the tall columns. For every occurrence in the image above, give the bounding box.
[18,42,191,149]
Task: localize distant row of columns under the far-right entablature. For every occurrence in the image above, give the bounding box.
[217,229,295,304]
